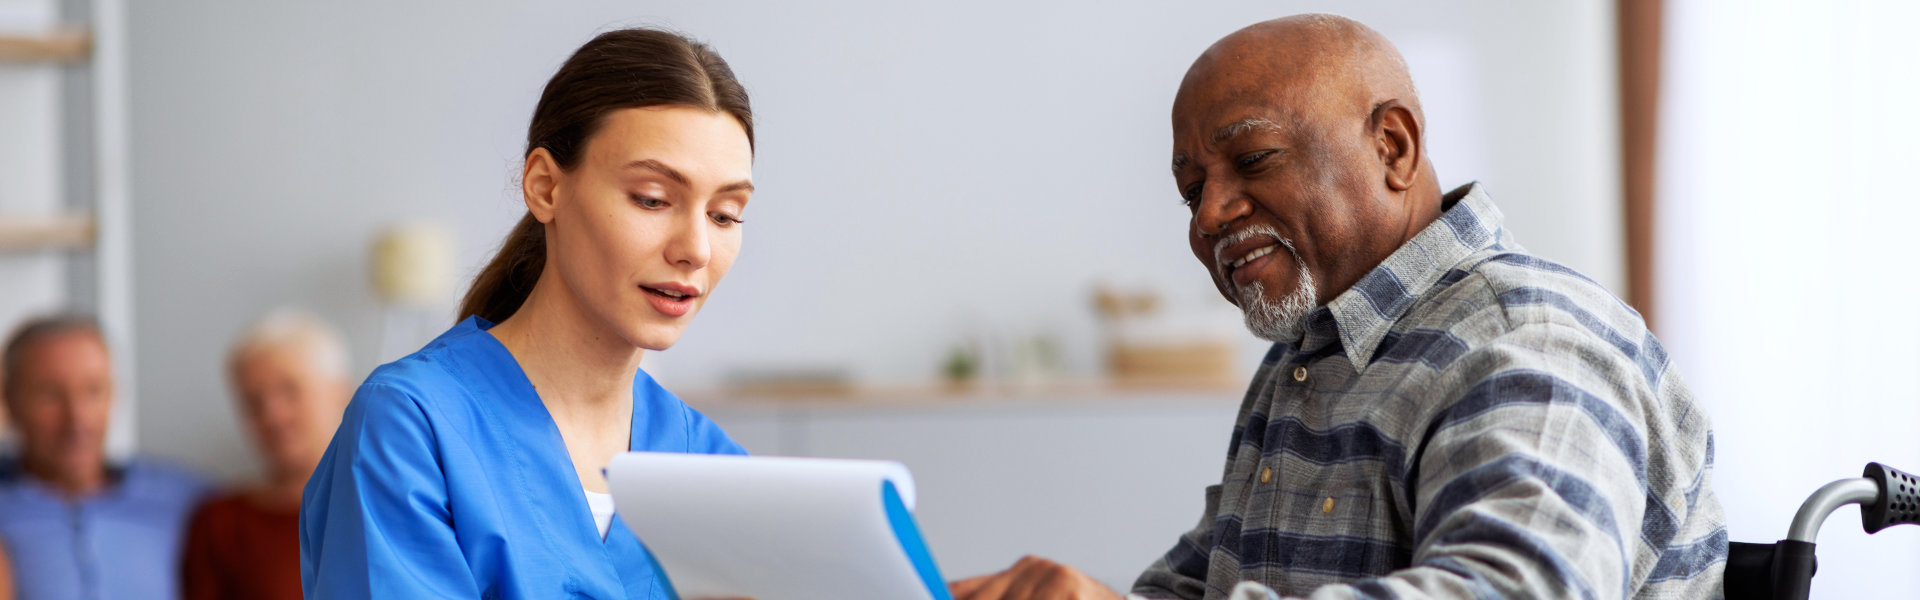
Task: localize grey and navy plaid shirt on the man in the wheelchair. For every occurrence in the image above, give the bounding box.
[1133,185,1726,600]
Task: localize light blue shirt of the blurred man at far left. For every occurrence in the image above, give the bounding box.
[0,460,205,600]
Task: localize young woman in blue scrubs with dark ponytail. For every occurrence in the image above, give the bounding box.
[300,29,753,598]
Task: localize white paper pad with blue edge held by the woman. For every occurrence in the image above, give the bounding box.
[607,452,950,600]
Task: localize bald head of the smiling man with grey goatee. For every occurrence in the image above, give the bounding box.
[1173,15,1440,340]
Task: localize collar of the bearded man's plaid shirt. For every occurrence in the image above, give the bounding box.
[1302,183,1505,371]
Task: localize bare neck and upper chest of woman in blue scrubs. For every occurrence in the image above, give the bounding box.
[488,269,643,409]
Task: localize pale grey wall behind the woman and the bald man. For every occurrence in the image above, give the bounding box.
[129,0,1620,475]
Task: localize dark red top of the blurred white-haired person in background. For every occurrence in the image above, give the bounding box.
[180,492,300,600]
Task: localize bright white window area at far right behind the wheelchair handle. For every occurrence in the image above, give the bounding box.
[1657,0,1920,598]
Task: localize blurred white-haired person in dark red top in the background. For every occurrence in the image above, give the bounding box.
[182,310,353,600]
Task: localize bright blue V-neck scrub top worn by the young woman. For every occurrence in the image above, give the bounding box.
[300,317,747,600]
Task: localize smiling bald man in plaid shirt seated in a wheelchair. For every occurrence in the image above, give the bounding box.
[952,15,1726,600]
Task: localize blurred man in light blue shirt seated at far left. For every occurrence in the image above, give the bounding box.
[0,315,204,600]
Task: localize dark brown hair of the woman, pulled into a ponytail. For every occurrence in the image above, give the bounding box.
[459,29,753,323]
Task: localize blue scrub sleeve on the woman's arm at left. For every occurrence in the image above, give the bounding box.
[300,385,480,598]
